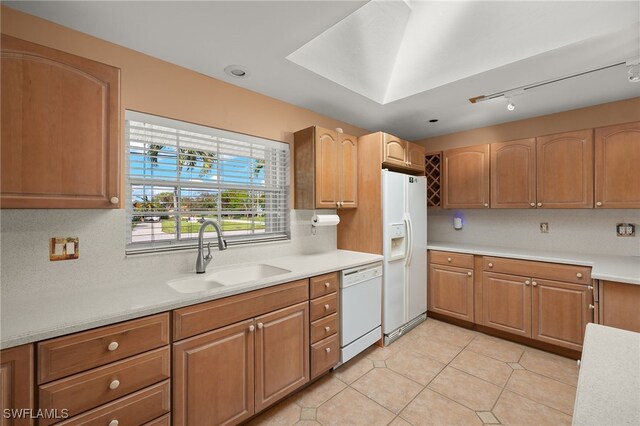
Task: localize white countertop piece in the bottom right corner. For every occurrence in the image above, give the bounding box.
[573,323,640,426]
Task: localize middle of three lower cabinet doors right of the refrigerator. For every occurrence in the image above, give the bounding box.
[482,272,531,337]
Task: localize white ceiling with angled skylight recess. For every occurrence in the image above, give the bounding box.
[3,0,640,140]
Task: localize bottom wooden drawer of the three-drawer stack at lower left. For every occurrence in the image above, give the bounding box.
[58,380,171,426]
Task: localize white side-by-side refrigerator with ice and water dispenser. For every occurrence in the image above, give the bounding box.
[382,170,427,345]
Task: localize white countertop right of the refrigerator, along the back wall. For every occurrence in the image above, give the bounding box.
[427,242,640,285]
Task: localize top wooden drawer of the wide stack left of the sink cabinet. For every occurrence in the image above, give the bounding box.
[38,313,169,384]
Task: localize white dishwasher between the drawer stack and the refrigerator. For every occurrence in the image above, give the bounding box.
[340,263,382,364]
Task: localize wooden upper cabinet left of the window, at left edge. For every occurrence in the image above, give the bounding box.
[0,34,122,208]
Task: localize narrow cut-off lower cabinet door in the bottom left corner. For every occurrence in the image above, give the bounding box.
[0,345,35,426]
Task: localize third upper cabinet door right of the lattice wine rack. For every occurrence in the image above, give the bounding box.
[536,130,593,209]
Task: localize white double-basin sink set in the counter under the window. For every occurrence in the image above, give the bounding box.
[167,263,291,293]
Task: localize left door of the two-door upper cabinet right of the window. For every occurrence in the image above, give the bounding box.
[308,127,339,209]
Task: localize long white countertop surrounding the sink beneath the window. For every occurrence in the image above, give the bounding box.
[0,250,382,349]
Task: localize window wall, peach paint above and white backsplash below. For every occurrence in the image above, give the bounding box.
[0,7,356,303]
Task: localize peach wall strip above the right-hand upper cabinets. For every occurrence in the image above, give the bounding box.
[416,97,640,152]
